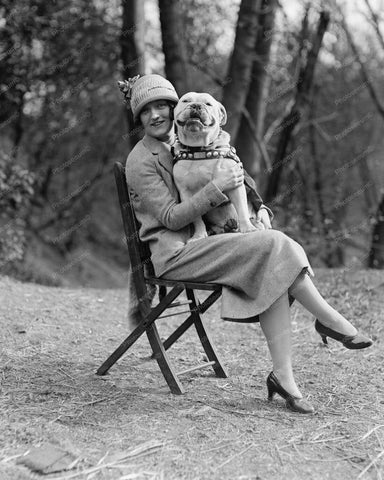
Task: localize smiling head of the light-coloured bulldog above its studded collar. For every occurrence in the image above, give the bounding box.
[174,92,227,147]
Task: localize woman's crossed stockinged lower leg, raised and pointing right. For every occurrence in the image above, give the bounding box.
[288,273,357,335]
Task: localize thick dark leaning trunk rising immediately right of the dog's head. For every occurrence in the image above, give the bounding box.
[223,0,261,144]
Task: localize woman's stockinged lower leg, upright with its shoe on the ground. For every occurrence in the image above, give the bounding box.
[259,293,302,398]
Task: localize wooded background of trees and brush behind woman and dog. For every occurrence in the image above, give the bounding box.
[0,0,384,287]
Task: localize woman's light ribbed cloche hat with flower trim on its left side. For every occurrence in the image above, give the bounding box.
[118,73,179,120]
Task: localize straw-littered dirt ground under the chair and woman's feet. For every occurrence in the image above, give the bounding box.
[0,270,384,480]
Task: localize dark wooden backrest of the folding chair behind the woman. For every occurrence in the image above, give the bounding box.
[114,162,153,300]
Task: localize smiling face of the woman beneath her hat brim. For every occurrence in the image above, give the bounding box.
[140,100,173,140]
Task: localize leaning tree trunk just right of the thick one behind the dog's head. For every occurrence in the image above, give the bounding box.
[236,0,278,178]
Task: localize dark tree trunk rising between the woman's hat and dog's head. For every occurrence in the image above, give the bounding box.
[159,0,190,96]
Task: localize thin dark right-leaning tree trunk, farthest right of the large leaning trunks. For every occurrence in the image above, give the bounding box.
[264,11,329,202]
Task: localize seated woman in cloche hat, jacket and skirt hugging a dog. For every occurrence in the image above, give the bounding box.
[120,75,372,413]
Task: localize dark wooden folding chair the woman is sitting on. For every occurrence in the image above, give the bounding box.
[97,162,227,394]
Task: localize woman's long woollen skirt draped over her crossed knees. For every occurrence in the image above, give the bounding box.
[155,230,313,322]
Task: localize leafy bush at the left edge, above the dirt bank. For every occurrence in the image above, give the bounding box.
[0,153,35,267]
